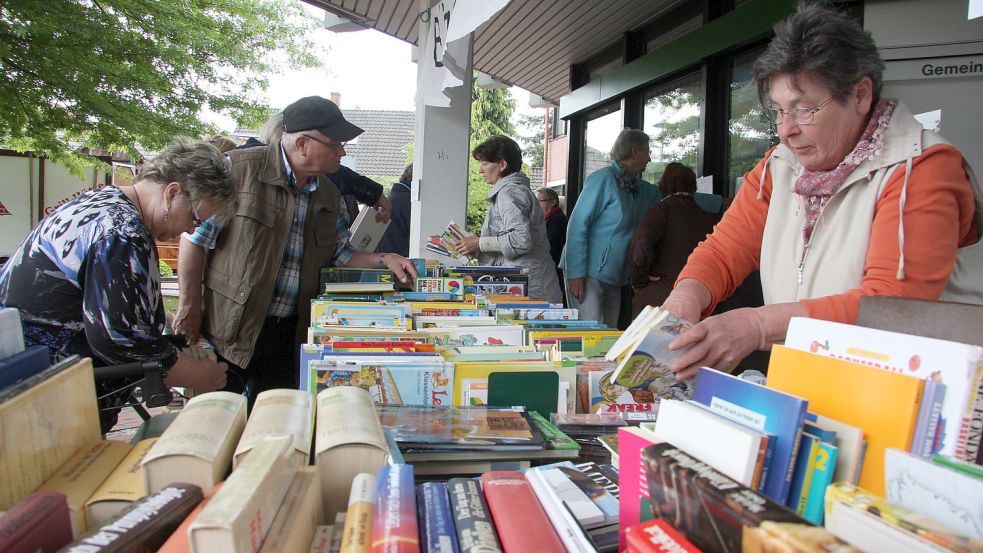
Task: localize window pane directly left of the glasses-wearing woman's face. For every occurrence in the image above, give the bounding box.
[727,48,778,196]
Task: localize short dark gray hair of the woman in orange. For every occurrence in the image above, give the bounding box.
[754,3,884,106]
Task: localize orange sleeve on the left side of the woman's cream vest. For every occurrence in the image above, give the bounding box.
[676,151,771,317]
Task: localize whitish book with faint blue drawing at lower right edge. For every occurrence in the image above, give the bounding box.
[884,449,983,540]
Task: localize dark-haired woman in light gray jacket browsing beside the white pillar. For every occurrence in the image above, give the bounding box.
[454,136,563,303]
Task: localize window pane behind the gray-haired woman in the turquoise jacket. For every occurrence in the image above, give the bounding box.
[642,69,703,183]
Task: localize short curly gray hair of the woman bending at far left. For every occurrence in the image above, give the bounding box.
[137,136,238,223]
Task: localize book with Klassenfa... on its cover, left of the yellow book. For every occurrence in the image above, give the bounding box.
[308,357,454,406]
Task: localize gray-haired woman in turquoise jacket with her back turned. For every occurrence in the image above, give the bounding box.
[560,129,661,328]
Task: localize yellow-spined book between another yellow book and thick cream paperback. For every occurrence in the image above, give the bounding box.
[85,438,157,527]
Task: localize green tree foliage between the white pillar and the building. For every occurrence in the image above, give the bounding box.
[466,80,515,234]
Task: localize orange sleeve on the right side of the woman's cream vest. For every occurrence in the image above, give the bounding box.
[800,145,977,324]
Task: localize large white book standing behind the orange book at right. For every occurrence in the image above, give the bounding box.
[785,317,983,461]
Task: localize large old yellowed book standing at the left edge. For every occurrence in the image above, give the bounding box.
[0,357,102,510]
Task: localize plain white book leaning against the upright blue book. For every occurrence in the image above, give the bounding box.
[655,399,767,487]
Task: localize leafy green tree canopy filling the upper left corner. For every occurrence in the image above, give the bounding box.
[0,0,320,167]
